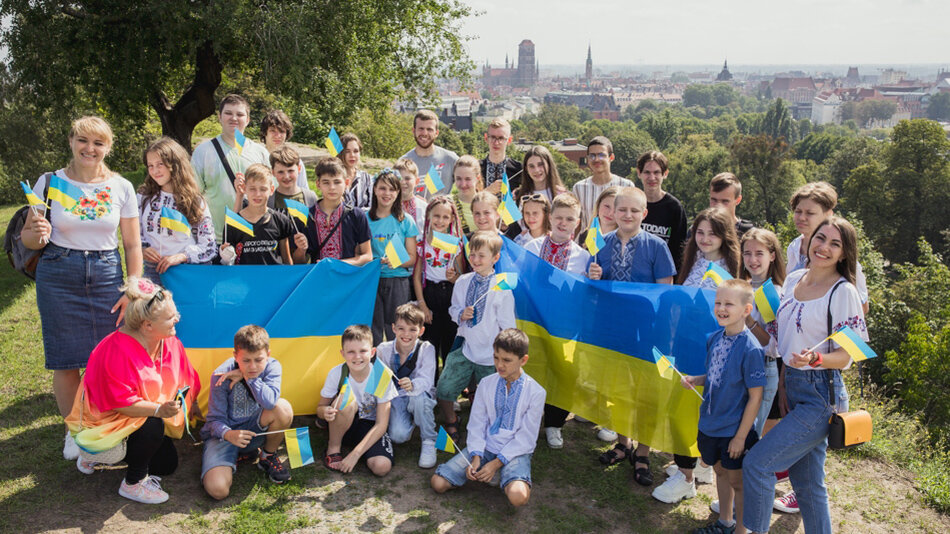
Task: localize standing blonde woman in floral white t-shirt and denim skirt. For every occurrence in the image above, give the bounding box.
[21,117,142,460]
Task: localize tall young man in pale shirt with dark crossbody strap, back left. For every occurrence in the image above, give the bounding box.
[191,94,276,243]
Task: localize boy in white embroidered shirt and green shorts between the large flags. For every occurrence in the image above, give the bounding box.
[436,231,515,443]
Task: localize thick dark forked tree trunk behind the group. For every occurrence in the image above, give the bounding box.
[151,41,222,154]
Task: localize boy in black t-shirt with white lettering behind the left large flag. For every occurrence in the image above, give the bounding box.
[221,163,307,265]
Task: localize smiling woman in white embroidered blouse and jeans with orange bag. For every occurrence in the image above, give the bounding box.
[742,217,867,532]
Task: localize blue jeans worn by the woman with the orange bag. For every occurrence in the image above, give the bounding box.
[742,367,848,534]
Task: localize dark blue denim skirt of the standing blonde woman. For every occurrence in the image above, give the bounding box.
[36,243,122,370]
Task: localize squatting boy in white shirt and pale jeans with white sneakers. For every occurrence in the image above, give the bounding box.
[376,302,438,469]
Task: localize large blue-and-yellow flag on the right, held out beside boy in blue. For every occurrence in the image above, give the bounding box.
[495,239,718,456]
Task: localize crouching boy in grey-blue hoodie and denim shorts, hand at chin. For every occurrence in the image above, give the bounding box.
[201,324,294,500]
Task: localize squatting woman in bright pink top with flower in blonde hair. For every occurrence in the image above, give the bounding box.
[66,277,201,504]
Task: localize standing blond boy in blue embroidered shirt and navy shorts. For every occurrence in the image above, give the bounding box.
[682,279,766,534]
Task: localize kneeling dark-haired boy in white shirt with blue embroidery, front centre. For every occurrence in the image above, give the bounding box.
[430,328,546,506]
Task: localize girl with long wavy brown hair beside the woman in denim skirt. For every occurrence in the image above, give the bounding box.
[138,137,217,283]
